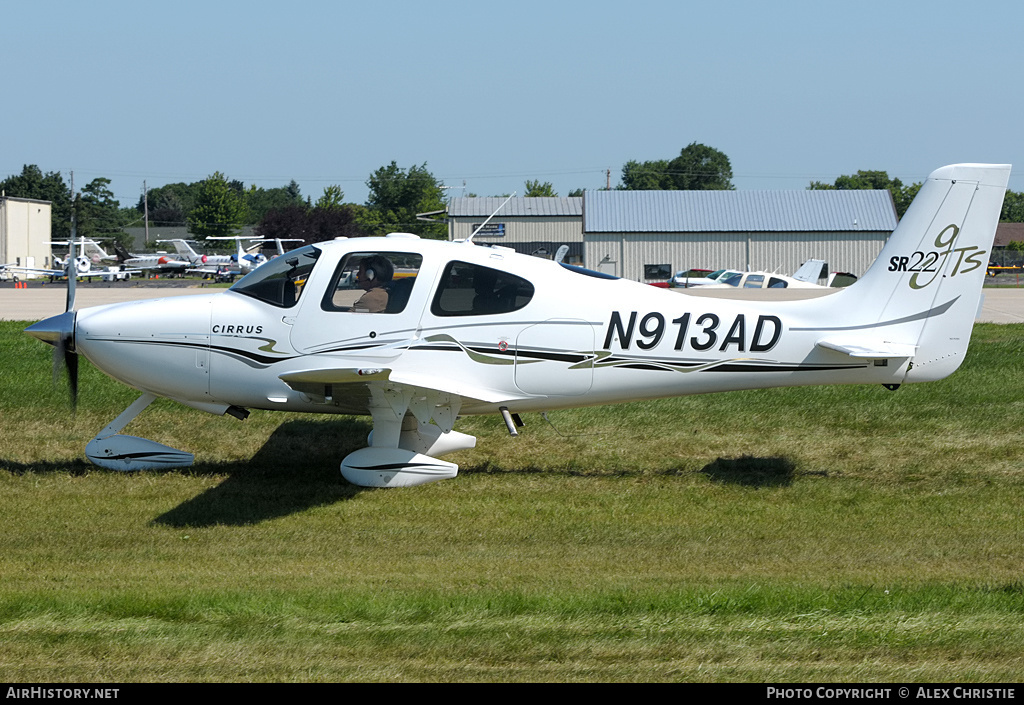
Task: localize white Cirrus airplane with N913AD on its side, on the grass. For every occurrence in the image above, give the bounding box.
[26,164,1010,487]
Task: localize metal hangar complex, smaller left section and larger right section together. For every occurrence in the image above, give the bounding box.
[449,190,897,282]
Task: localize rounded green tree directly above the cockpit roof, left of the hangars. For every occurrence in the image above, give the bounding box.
[359,161,447,240]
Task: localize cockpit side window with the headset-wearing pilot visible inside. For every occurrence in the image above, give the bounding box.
[321,251,423,314]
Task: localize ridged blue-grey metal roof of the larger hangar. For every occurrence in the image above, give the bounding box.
[583,191,897,233]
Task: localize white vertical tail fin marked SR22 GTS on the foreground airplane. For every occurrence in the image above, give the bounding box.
[847,164,1010,382]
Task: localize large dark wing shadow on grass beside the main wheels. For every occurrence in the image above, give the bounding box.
[154,418,372,527]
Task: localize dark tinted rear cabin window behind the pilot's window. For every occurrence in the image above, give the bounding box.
[430,261,534,316]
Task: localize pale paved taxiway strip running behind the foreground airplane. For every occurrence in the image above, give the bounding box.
[0,282,1024,323]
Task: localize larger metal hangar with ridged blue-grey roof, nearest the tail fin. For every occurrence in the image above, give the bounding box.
[583,191,897,282]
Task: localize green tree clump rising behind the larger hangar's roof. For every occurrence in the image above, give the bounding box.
[622,142,734,191]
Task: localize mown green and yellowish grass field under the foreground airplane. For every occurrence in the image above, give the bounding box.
[0,324,1024,682]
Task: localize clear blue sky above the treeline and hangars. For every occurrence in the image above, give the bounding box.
[0,0,1024,206]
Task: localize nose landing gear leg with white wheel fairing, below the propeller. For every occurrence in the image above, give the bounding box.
[85,392,196,471]
